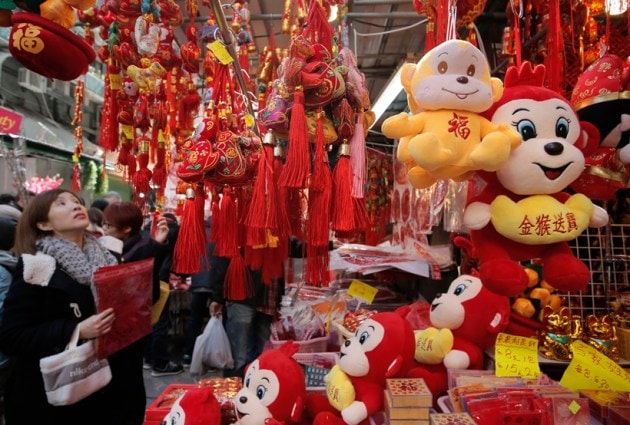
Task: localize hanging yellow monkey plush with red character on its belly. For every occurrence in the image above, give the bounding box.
[381,40,521,188]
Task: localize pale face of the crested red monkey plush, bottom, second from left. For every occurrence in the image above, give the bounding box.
[234,360,280,425]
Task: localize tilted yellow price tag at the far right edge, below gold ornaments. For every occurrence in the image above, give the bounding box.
[560,341,630,391]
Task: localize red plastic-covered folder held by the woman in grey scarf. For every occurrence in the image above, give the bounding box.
[94,258,153,359]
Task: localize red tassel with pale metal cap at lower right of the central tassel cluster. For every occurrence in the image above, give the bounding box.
[332,143,355,232]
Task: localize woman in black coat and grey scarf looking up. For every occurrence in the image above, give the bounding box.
[0,189,117,425]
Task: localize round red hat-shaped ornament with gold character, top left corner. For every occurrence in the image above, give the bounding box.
[9,12,96,81]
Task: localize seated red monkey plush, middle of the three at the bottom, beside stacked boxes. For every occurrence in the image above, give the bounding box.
[307,312,415,425]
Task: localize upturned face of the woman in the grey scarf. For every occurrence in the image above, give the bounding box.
[37,192,90,237]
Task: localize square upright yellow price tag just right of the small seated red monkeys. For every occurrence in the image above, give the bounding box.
[494,333,540,378]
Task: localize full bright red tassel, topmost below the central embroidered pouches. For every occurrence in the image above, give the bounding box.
[279,87,310,188]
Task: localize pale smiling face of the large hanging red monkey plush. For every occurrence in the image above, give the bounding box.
[492,96,584,195]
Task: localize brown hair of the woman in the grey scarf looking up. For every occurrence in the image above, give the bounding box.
[13,189,81,256]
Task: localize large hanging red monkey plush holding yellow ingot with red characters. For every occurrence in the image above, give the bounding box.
[464,62,608,296]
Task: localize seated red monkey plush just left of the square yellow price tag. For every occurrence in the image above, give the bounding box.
[409,275,510,400]
